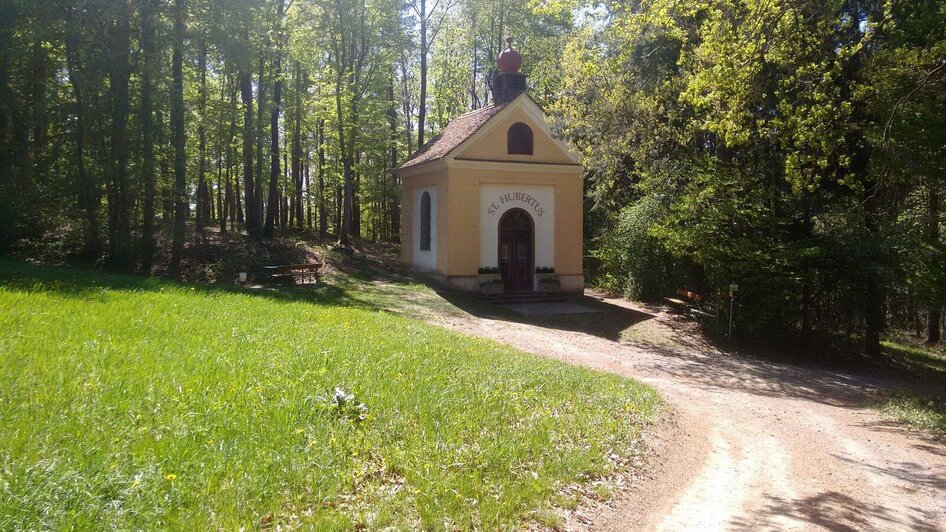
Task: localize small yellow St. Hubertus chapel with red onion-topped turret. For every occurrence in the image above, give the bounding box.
[397,39,584,295]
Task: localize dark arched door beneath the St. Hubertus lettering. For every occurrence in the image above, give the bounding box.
[499,209,535,293]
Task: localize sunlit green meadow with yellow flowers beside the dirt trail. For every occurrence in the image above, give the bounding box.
[0,261,659,530]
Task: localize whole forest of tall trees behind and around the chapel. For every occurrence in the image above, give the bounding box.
[0,0,946,356]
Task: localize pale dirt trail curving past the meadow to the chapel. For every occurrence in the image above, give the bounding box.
[435,299,946,530]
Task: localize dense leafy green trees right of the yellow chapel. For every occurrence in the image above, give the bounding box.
[553,0,946,348]
